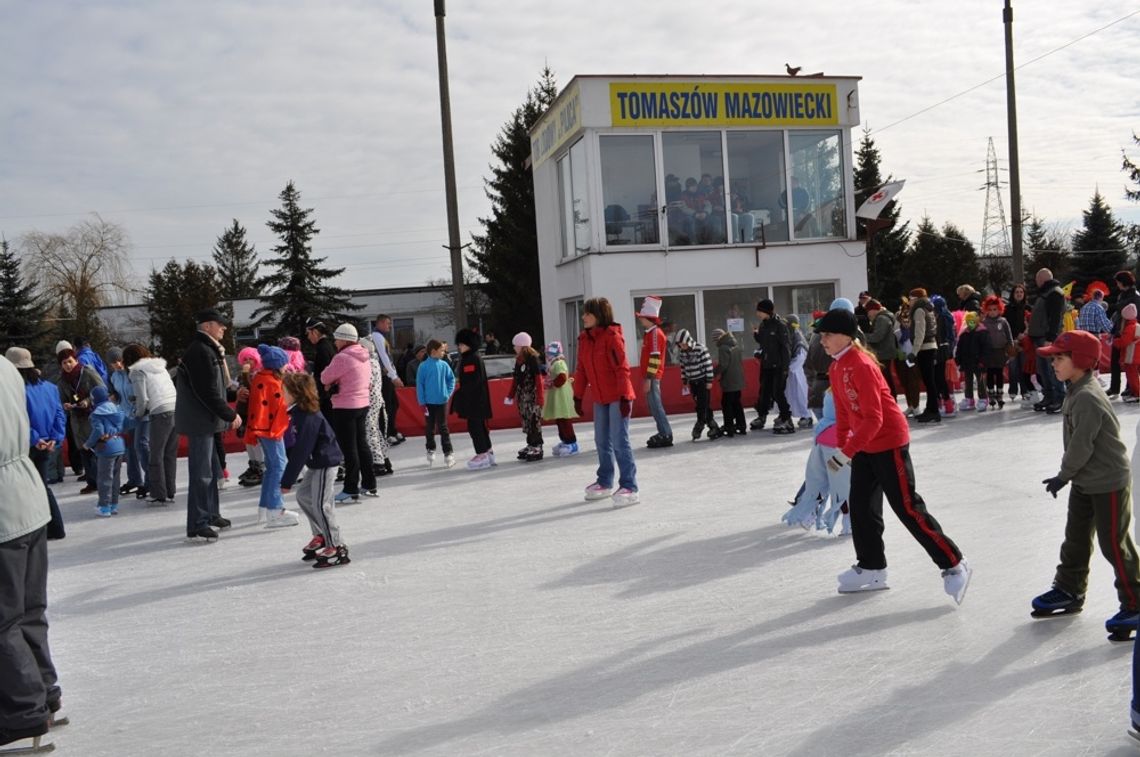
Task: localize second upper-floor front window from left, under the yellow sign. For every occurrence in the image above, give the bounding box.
[661,131,727,246]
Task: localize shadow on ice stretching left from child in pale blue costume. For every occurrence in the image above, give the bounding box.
[540,524,846,599]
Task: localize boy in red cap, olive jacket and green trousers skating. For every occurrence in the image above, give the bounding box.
[1032,329,1140,641]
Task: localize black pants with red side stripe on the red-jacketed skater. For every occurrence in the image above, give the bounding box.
[848,445,962,570]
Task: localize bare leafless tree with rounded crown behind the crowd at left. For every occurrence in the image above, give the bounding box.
[21,213,130,347]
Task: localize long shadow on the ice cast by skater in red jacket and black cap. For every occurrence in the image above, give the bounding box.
[377,596,953,755]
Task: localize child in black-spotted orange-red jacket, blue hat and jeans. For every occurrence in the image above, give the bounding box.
[245,344,300,528]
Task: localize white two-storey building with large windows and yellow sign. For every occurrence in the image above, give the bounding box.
[531,76,866,364]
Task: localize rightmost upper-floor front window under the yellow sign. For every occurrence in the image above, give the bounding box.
[781,131,847,239]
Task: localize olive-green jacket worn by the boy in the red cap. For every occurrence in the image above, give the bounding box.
[1059,372,1132,494]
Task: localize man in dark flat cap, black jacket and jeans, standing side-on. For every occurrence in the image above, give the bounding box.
[174,308,242,540]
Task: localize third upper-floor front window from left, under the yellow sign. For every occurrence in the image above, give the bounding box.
[728,131,788,244]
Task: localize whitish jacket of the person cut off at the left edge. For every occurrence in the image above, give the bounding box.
[0,360,51,544]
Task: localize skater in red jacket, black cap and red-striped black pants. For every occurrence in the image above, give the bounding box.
[816,310,971,604]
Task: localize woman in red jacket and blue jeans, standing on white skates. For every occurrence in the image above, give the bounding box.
[573,298,641,507]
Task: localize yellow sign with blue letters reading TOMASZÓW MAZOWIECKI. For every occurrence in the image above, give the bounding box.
[610,81,839,127]
